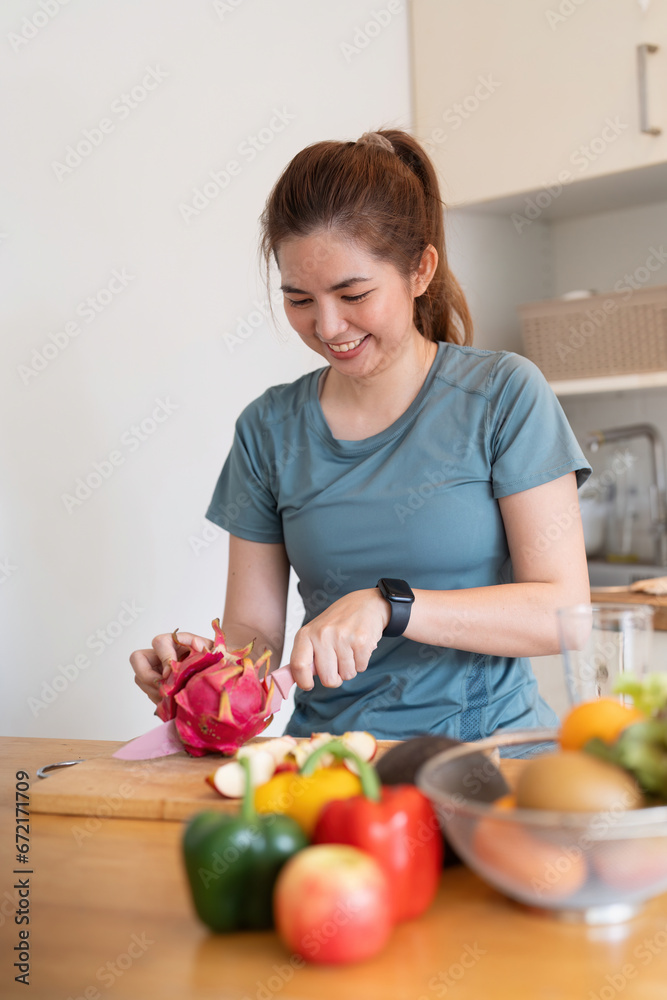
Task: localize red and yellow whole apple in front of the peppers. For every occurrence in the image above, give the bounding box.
[273,844,392,964]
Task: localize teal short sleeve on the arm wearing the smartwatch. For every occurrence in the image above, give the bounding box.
[486,352,592,499]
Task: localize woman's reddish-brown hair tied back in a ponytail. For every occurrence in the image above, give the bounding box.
[261,129,472,344]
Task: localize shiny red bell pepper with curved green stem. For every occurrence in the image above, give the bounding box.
[302,741,444,923]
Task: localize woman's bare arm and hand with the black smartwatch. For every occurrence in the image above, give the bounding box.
[290,472,590,689]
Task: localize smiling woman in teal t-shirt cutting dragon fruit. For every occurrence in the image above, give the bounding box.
[131,130,590,740]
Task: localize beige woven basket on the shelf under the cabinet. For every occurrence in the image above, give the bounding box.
[518,285,667,382]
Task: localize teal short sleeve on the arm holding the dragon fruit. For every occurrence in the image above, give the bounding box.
[206,400,283,542]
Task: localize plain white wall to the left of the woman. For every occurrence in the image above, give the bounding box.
[0,0,410,739]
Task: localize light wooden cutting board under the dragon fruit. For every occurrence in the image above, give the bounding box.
[30,737,396,820]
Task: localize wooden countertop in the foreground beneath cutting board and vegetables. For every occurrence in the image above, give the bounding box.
[0,738,667,1000]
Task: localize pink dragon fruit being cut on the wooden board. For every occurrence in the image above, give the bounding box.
[156,618,273,757]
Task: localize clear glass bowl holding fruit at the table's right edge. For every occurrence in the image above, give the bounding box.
[417,729,667,924]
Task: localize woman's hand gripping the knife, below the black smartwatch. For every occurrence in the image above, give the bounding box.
[290,588,391,691]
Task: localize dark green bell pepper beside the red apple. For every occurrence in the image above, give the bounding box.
[182,757,309,931]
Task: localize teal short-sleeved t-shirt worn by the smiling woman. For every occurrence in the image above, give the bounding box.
[206,343,591,740]
